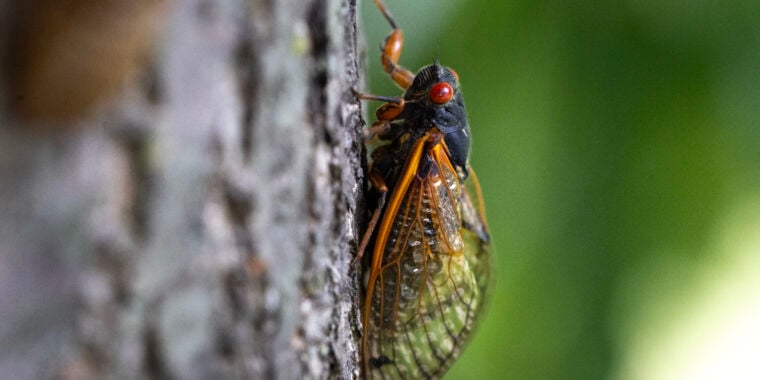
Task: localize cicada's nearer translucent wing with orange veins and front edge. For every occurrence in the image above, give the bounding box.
[363,140,487,379]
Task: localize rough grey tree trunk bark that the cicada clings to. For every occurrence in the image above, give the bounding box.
[0,0,363,379]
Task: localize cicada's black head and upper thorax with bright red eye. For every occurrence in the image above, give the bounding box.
[398,63,470,179]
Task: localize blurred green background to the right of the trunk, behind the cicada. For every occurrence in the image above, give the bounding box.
[361,0,760,380]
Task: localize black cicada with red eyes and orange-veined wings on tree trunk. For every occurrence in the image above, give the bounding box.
[358,0,490,379]
